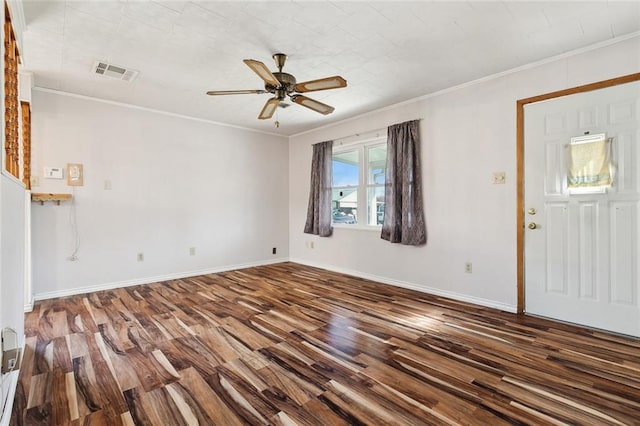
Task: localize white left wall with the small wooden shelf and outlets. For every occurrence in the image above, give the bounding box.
[32,93,289,298]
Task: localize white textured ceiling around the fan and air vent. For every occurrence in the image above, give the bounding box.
[17,0,640,135]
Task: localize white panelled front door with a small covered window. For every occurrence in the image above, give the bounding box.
[524,82,640,336]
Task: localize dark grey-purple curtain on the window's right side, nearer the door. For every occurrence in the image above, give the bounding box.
[380,120,427,246]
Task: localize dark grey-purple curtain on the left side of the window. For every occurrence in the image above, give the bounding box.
[304,141,333,237]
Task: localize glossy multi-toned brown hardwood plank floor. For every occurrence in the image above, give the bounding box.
[12,263,640,425]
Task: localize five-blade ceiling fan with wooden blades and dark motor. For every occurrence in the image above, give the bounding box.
[207,53,347,120]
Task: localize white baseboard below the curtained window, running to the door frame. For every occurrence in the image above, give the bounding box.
[290,258,518,313]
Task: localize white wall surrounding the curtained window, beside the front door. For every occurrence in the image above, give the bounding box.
[289,37,640,310]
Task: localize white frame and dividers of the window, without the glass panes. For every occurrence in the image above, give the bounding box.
[331,134,387,232]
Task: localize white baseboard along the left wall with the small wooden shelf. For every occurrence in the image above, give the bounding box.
[32,257,289,302]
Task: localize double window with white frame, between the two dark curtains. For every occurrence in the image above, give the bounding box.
[331,138,387,226]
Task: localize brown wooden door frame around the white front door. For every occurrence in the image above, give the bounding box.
[516,73,640,314]
